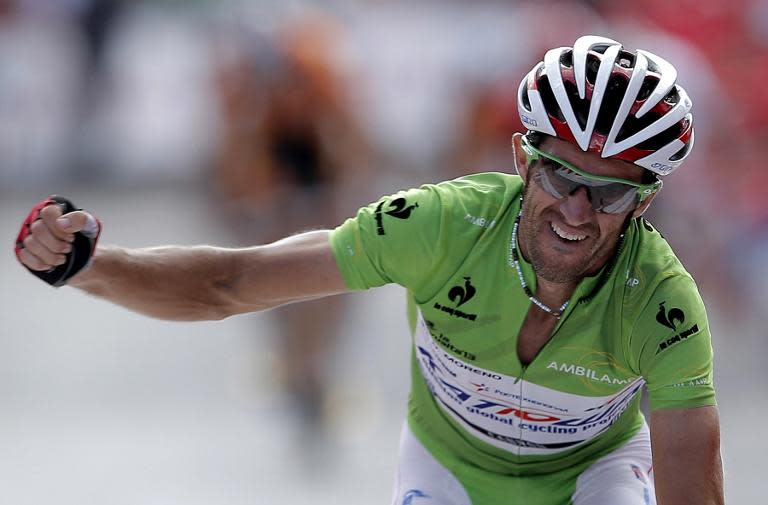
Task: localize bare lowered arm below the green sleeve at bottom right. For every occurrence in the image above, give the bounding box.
[651,407,724,505]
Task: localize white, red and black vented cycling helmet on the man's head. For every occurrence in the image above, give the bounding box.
[517,35,694,175]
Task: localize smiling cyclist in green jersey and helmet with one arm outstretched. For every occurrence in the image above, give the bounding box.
[16,36,723,505]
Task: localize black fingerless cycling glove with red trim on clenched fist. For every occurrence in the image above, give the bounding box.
[15,195,101,287]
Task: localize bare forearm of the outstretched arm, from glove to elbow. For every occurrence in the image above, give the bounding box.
[70,246,249,321]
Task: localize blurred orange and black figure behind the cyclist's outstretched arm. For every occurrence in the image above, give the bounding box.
[213,13,373,436]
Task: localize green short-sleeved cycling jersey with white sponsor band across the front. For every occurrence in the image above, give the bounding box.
[331,173,715,503]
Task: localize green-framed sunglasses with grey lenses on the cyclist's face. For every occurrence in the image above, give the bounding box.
[522,136,662,214]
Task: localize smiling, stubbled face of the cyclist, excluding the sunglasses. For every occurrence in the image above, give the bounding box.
[514,136,653,284]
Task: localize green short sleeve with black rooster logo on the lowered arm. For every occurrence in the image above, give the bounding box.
[631,275,715,410]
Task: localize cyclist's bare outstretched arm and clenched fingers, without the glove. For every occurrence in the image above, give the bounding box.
[19,201,347,320]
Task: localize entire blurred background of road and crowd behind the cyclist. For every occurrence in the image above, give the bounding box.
[0,0,768,505]
